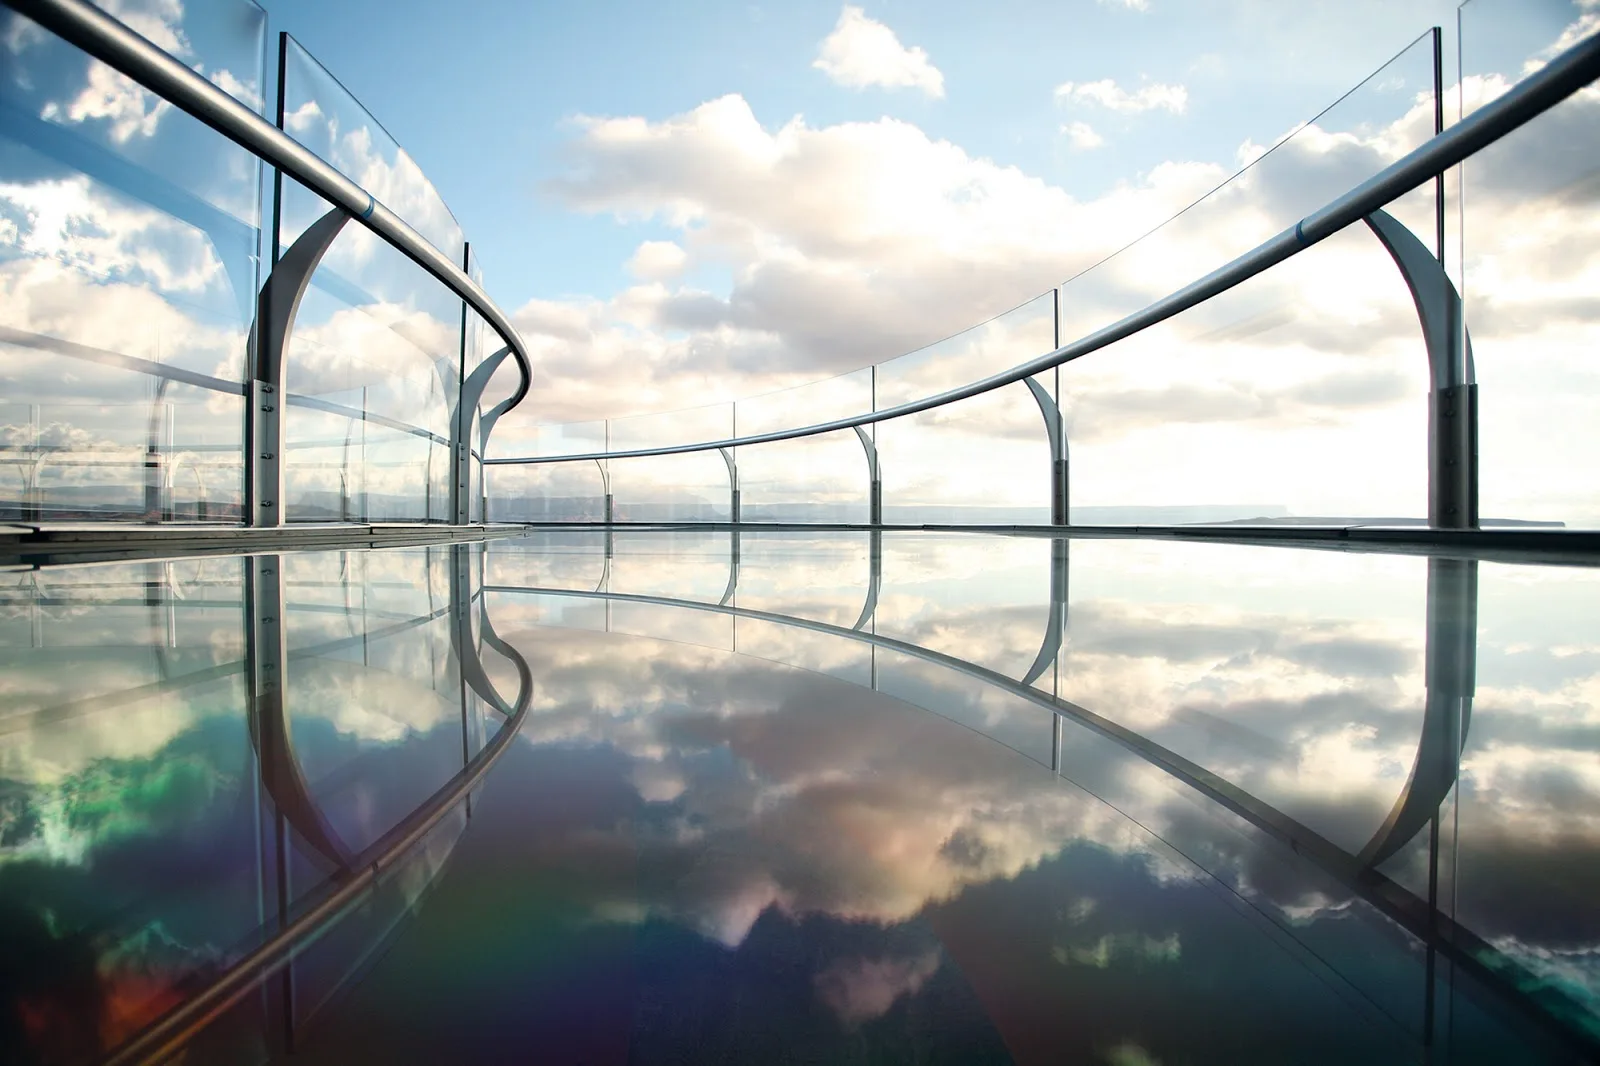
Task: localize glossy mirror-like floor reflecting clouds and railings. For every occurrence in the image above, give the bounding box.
[0,531,1600,1066]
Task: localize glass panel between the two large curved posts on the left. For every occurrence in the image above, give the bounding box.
[280,38,470,522]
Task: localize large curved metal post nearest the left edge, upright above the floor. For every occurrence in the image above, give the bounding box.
[245,208,350,527]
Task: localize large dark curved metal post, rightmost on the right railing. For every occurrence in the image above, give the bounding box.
[1366,204,1478,530]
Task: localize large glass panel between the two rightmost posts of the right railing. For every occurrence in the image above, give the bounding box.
[1061,37,1437,525]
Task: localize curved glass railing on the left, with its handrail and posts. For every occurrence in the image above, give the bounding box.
[0,0,530,527]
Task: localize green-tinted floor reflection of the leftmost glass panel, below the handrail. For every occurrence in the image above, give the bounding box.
[0,559,259,1061]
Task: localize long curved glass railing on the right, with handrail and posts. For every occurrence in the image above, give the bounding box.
[488,12,1600,528]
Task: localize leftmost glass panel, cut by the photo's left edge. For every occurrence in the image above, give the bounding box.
[0,0,266,522]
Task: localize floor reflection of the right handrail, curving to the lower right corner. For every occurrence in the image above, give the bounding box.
[483,584,1600,1055]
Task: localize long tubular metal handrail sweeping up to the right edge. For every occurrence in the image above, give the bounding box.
[483,35,1600,466]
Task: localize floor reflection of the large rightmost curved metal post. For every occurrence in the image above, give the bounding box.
[1357,559,1478,866]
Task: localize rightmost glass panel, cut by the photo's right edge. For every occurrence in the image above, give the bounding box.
[1461,0,1600,528]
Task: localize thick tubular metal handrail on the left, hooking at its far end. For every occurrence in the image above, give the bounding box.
[0,0,533,407]
